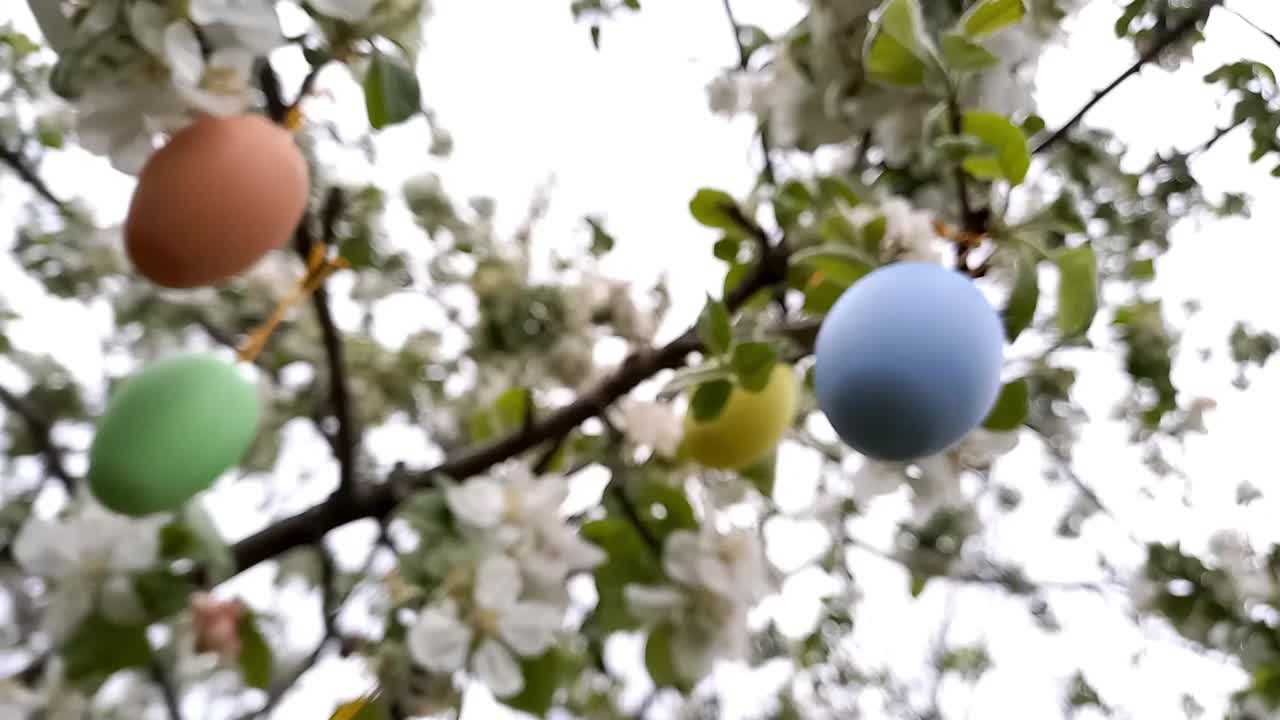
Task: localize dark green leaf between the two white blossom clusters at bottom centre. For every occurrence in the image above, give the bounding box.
[581,518,662,634]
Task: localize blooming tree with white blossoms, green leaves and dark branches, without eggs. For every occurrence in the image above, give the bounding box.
[0,0,1280,720]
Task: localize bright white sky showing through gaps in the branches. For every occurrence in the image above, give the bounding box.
[0,0,1280,720]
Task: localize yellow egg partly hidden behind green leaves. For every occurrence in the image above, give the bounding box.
[684,363,799,470]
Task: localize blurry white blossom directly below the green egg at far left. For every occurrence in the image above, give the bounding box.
[13,502,165,639]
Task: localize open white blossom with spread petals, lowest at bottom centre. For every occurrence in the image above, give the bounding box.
[408,555,562,697]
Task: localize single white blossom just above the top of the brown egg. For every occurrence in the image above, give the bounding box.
[164,22,253,115]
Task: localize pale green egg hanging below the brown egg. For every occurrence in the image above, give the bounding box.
[88,354,259,515]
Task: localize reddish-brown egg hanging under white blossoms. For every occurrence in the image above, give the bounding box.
[124,114,310,288]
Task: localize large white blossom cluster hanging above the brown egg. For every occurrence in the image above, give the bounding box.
[32,0,425,174]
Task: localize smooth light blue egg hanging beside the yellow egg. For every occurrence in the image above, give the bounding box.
[814,261,1005,460]
